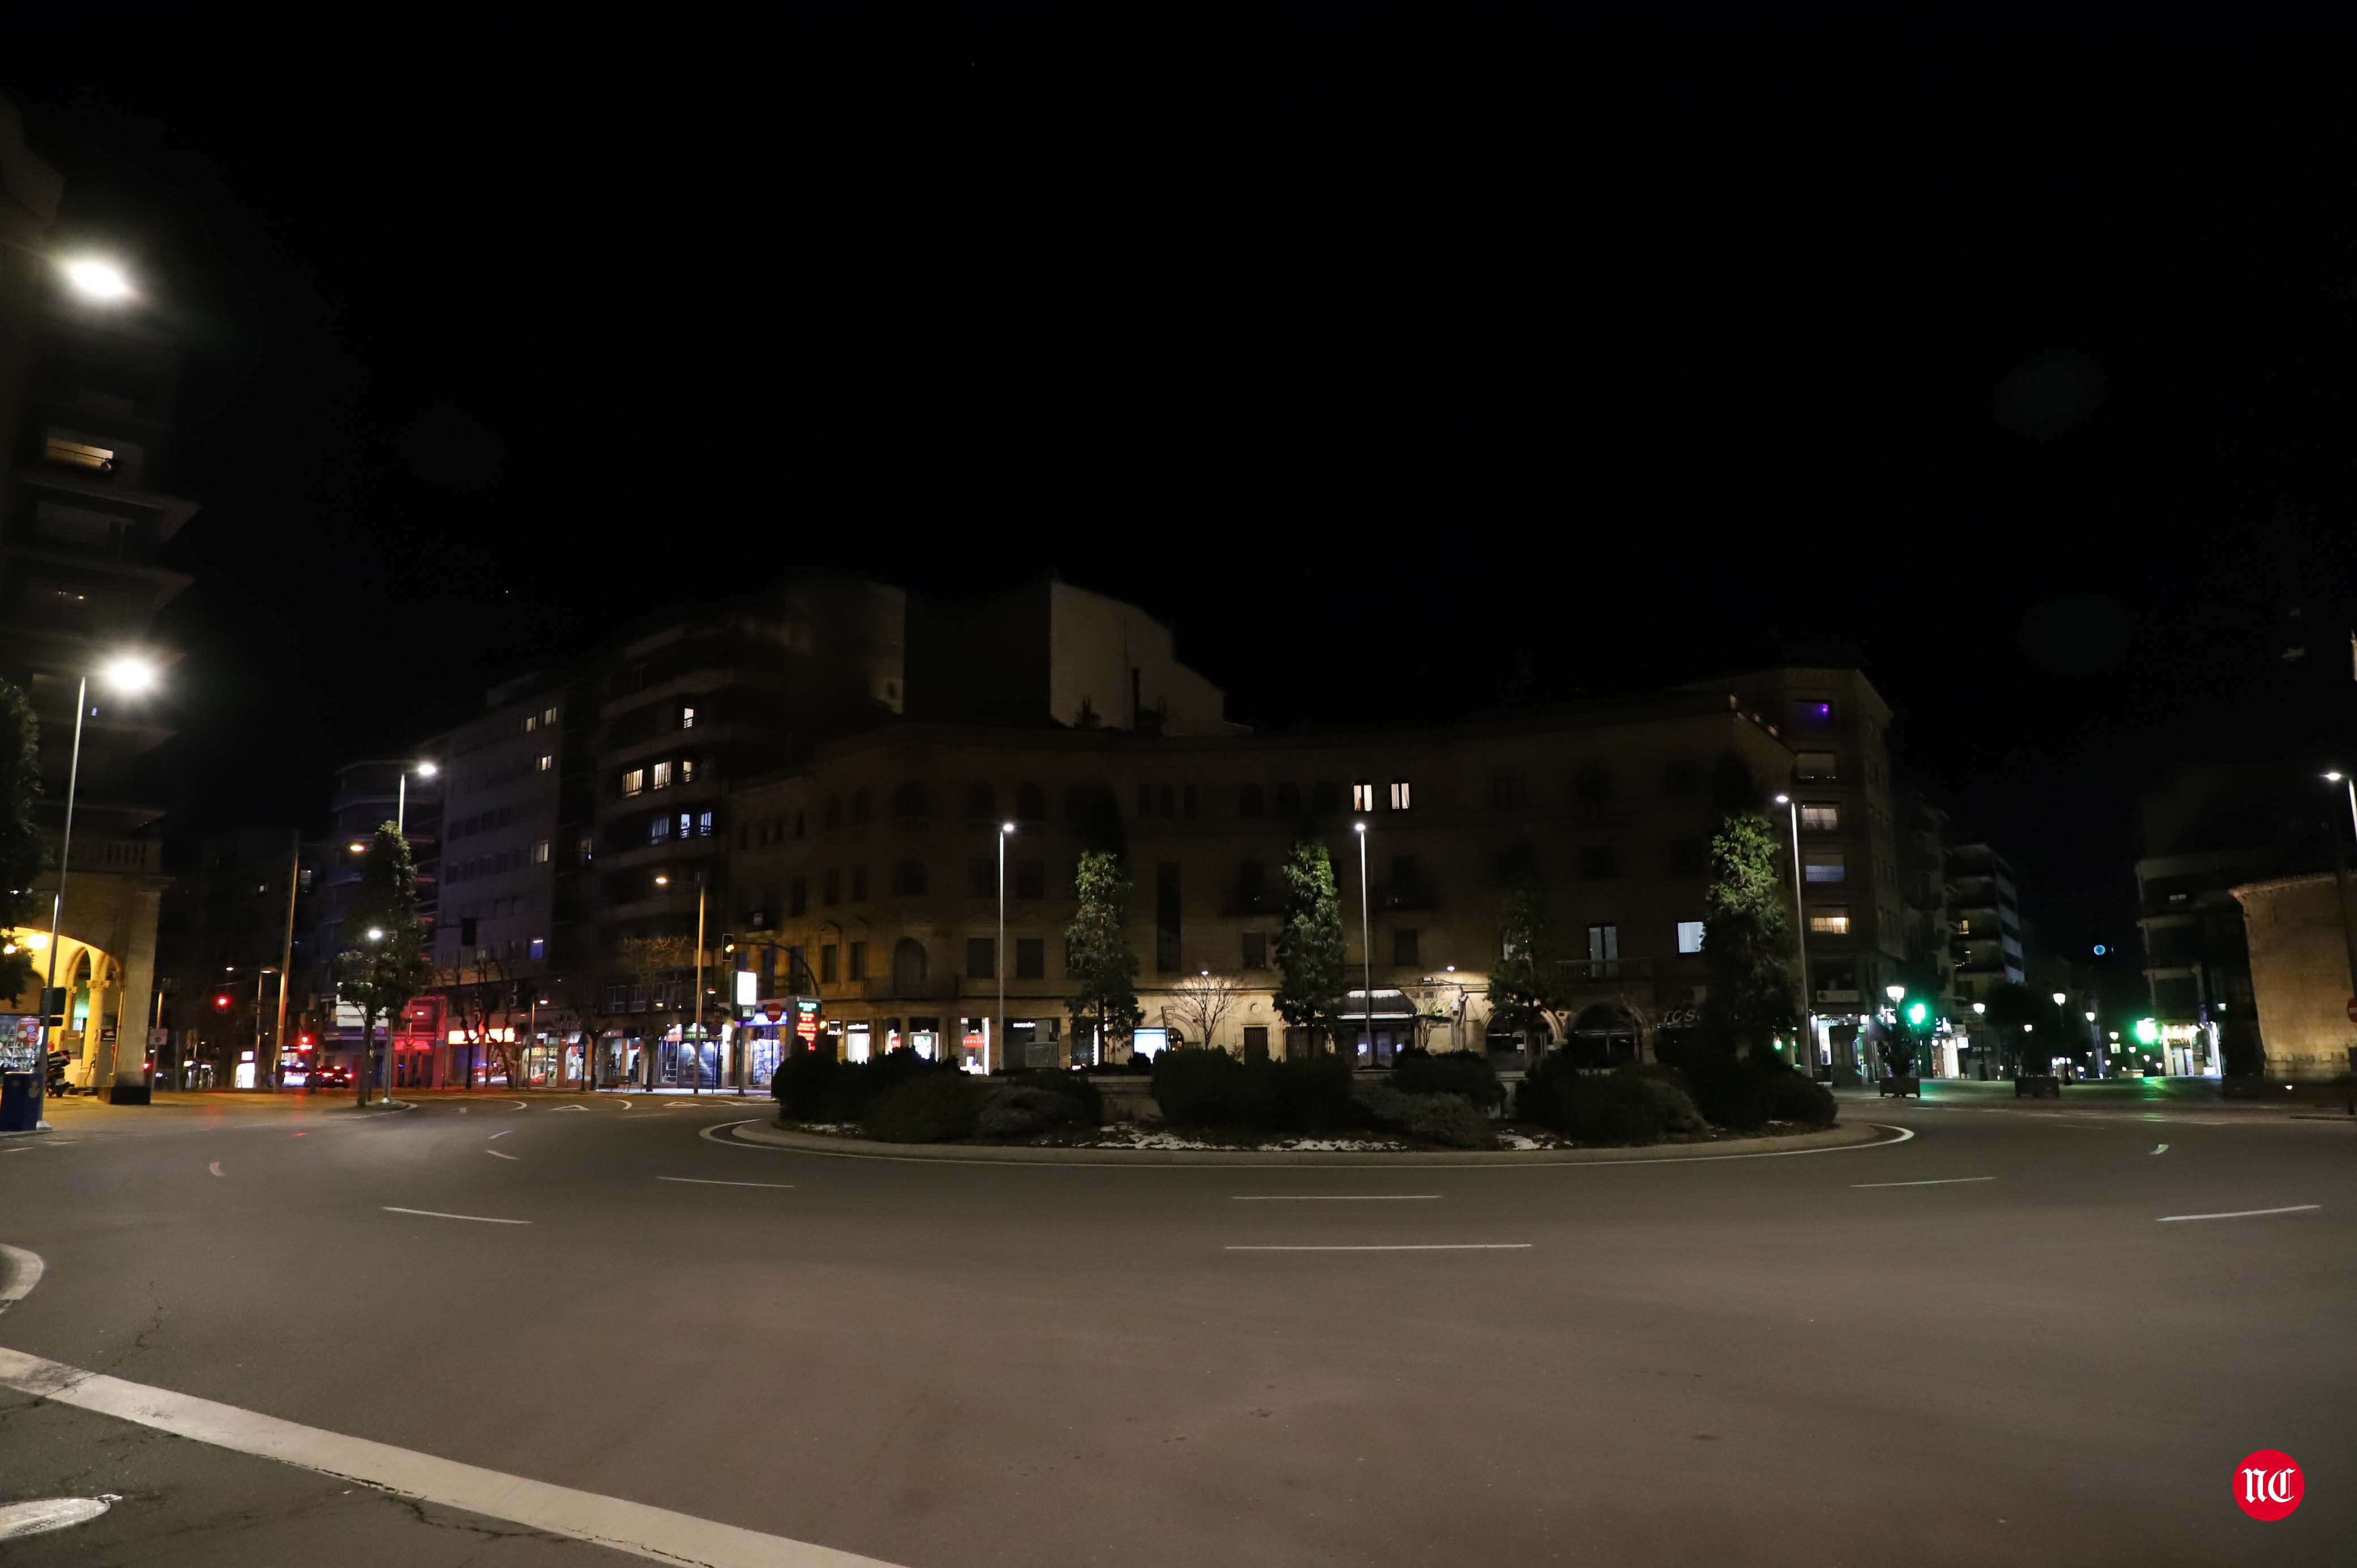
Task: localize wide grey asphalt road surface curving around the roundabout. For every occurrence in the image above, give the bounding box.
[0,1094,2357,1568]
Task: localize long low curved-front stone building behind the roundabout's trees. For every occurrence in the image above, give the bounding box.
[717,691,1794,1066]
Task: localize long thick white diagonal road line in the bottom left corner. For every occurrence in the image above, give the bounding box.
[0,1349,886,1568]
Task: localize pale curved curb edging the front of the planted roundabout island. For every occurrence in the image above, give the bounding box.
[721,1120,1914,1167]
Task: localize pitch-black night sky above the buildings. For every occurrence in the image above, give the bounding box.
[0,5,2357,945]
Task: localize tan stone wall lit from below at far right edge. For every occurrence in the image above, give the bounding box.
[2232,875,2357,1080]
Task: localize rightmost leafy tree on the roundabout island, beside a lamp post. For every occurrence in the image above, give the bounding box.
[1702,811,1796,1061]
